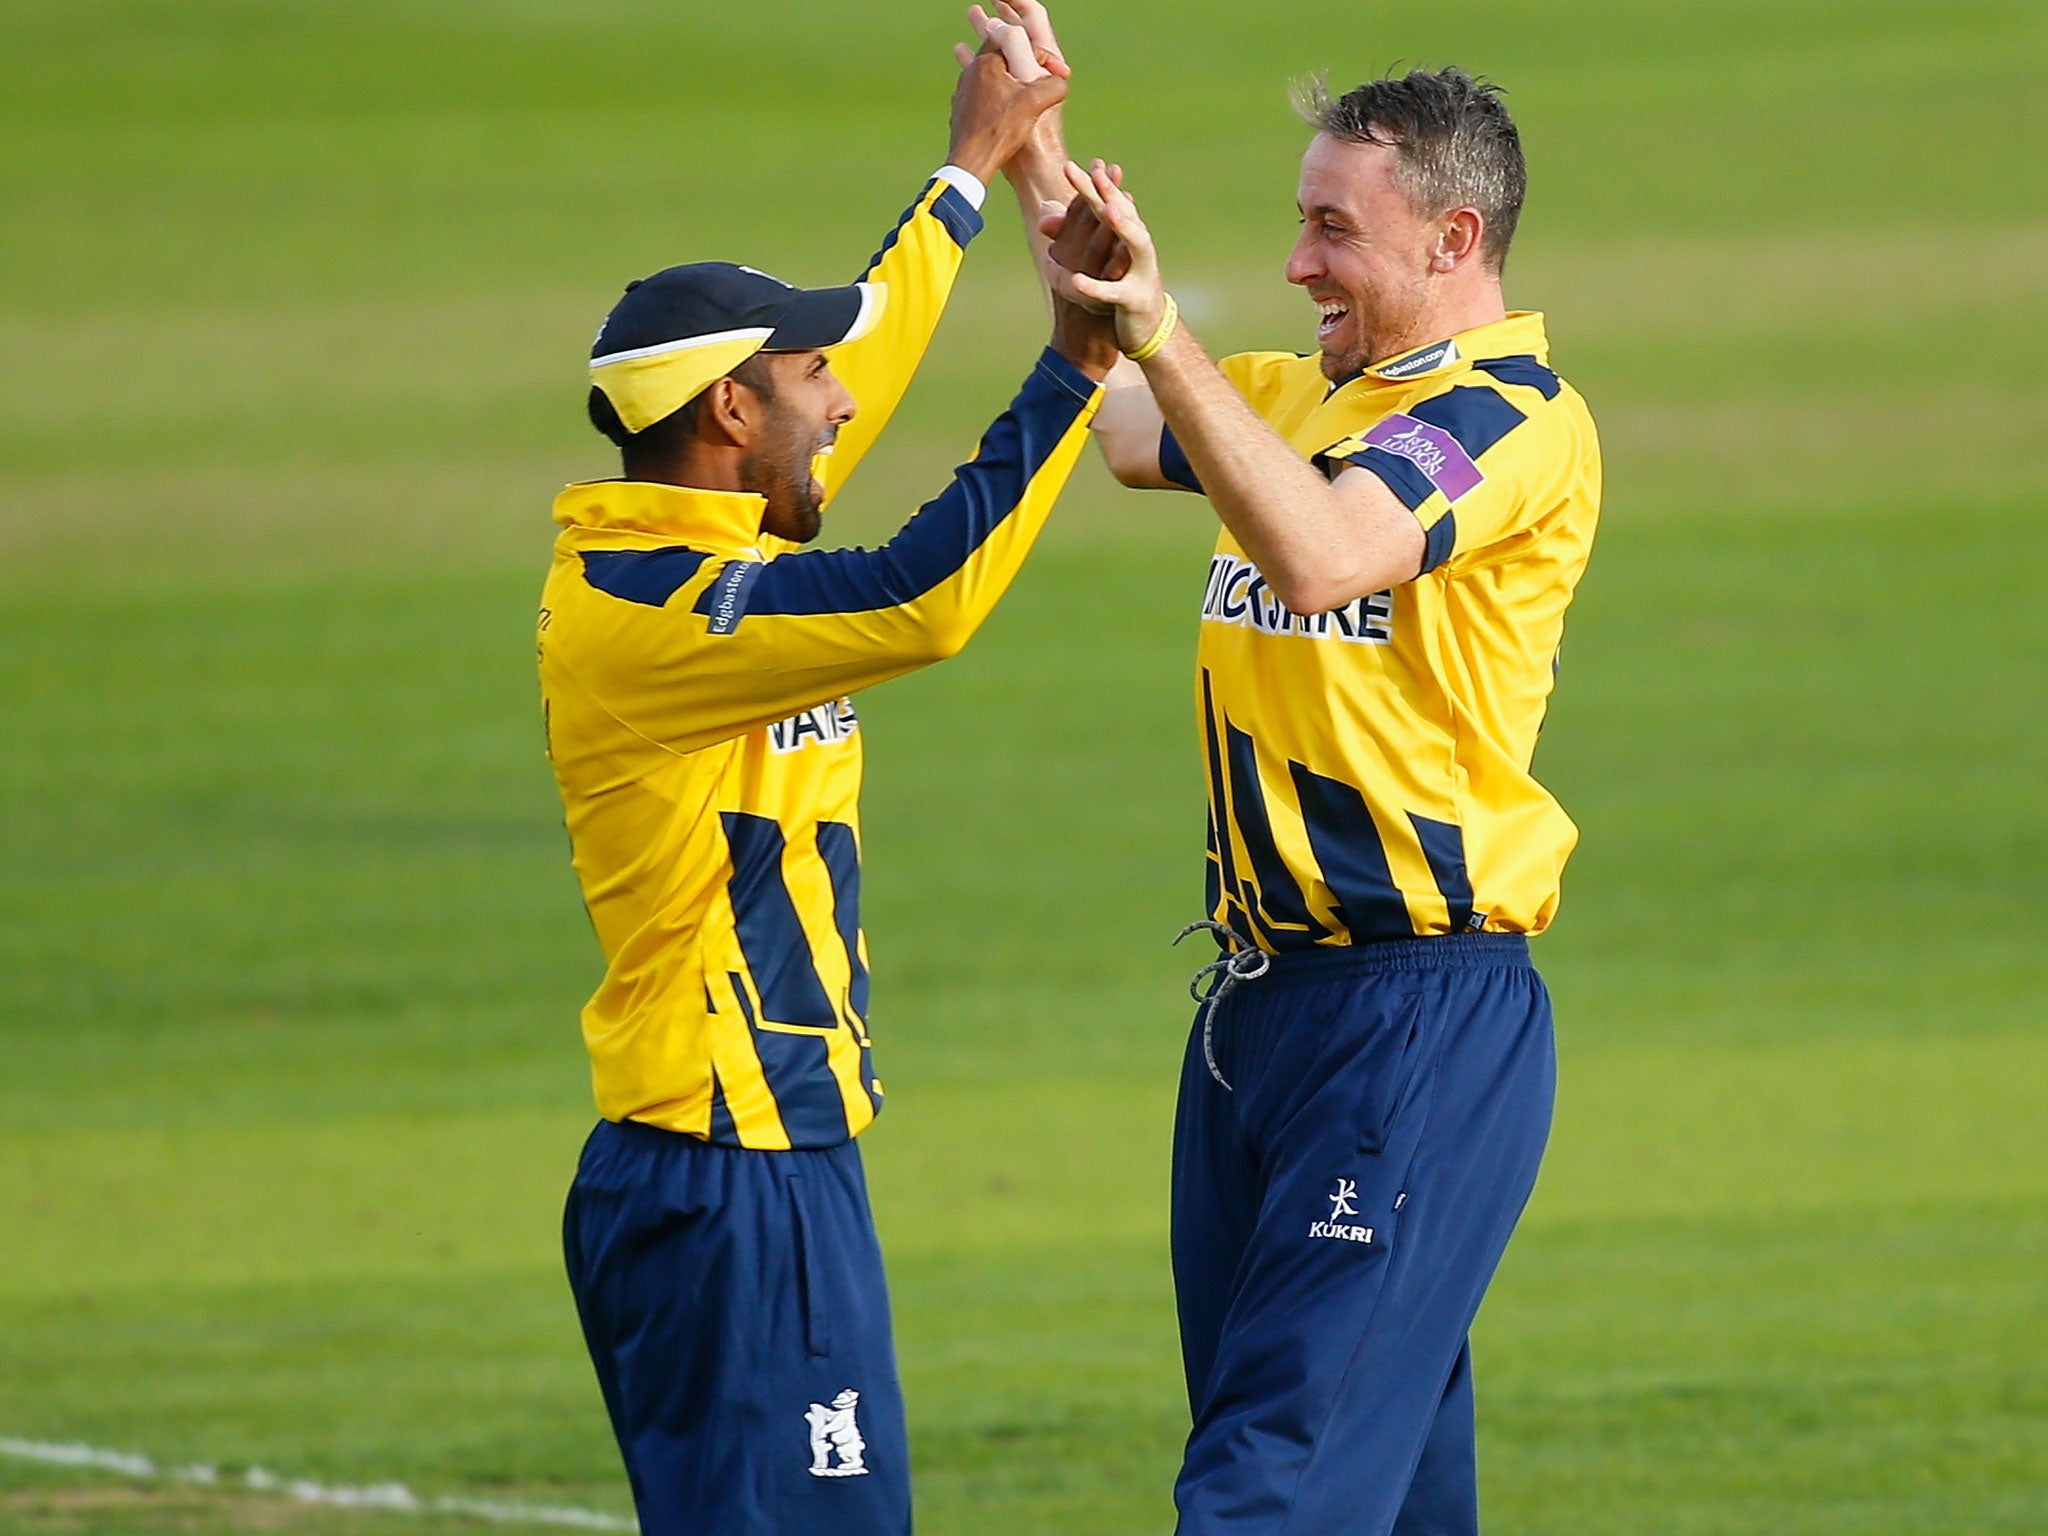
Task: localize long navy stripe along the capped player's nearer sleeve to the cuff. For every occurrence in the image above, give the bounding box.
[696,348,1096,623]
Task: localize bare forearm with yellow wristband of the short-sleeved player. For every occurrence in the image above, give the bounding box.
[1143,326,1399,614]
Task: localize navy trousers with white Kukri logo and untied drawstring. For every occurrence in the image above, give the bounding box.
[1174,934,1556,1536]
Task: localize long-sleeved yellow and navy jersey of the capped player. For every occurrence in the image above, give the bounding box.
[539,182,1098,1149]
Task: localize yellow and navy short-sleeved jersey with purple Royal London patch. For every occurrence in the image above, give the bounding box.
[1159,313,1599,952]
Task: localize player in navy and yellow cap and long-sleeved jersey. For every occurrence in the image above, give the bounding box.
[539,39,1116,1536]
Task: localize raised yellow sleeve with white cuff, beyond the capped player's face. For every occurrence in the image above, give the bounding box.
[815,172,981,506]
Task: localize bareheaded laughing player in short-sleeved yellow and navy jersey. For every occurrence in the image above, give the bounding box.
[981,0,1599,1536]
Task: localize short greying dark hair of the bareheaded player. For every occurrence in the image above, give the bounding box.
[1294,66,1528,270]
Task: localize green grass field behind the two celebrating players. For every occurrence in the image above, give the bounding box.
[0,0,2048,1536]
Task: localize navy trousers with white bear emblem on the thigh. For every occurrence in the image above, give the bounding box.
[563,1120,909,1536]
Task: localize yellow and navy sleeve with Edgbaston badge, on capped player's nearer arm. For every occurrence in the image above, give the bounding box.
[561,350,1100,752]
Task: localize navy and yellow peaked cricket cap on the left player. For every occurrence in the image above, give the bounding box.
[590,262,889,432]
